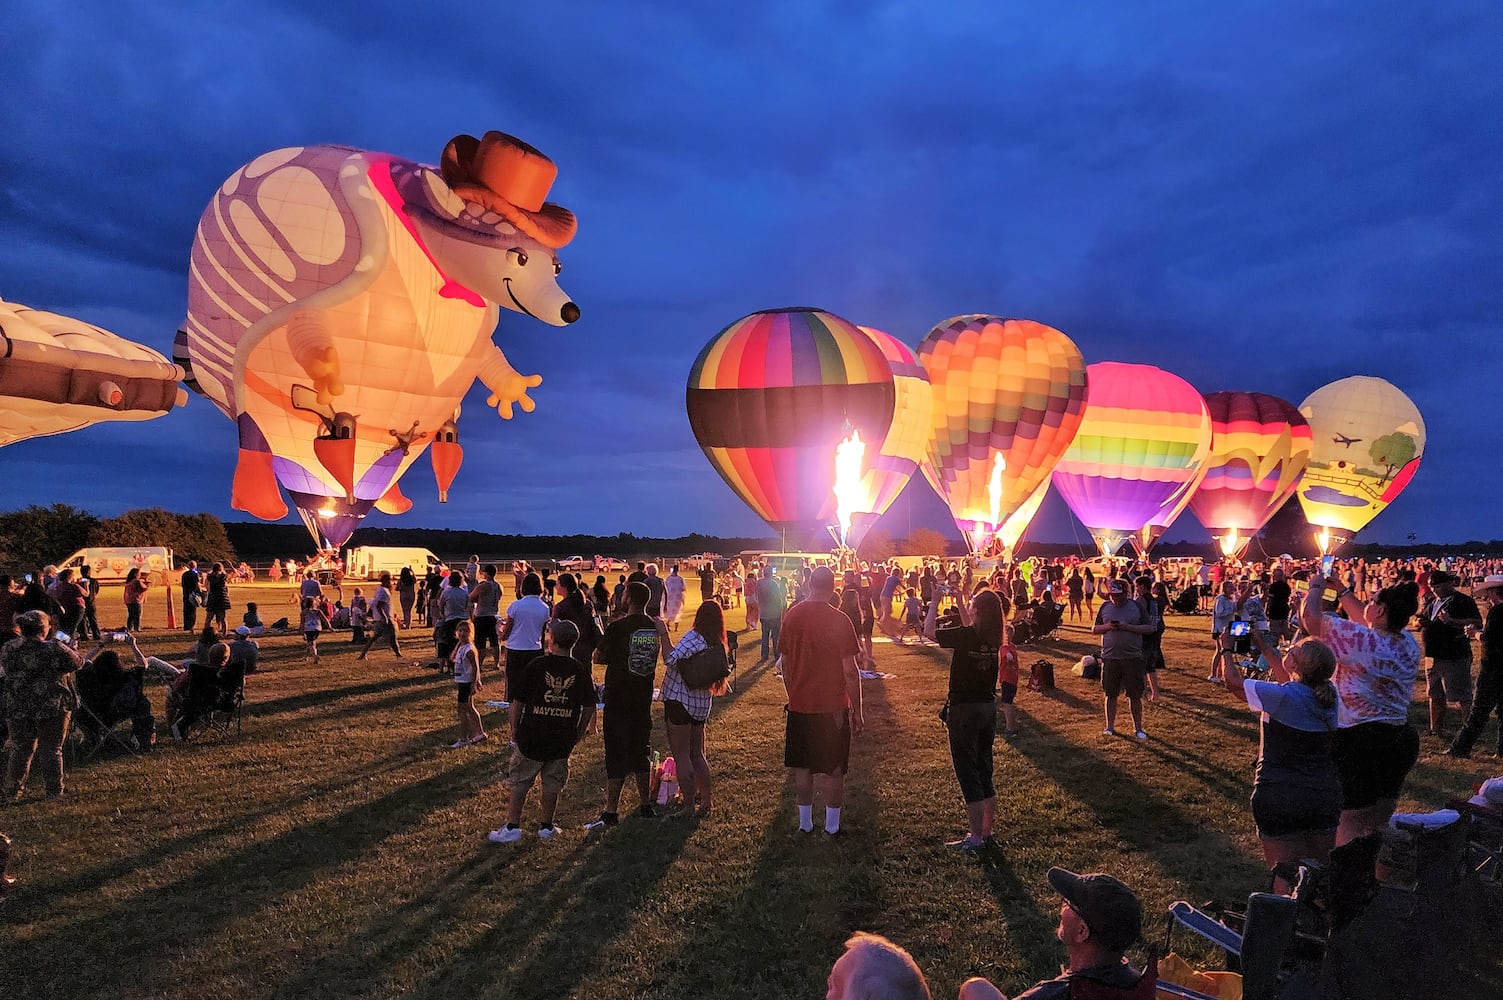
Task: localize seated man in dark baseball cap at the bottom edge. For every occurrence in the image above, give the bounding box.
[959,868,1153,1000]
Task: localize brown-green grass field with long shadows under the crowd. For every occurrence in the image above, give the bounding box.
[0,585,1503,1000]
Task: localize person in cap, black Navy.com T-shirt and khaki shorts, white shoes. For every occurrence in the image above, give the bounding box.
[487,620,595,844]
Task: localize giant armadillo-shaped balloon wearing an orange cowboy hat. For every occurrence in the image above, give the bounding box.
[174,132,579,546]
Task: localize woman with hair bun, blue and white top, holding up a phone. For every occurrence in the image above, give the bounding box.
[1226,632,1341,895]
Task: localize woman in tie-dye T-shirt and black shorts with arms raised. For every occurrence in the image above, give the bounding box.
[1300,573,1419,847]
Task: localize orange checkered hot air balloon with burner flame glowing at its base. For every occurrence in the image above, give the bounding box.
[918,316,1087,549]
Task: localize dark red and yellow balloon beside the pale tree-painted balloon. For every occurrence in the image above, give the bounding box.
[1190,392,1311,558]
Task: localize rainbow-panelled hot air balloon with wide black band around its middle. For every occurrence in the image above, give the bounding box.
[684,308,896,534]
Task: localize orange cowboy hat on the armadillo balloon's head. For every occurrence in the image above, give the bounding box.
[439,132,577,250]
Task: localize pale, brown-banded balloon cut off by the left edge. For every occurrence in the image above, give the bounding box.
[0,301,188,445]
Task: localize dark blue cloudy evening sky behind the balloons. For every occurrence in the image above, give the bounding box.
[0,0,1503,541]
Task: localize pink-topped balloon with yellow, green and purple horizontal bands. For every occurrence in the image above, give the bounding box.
[1054,361,1211,555]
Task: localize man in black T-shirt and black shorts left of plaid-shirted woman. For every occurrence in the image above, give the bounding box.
[585,580,669,830]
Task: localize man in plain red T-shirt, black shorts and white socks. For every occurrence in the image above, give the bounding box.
[777,567,863,835]
